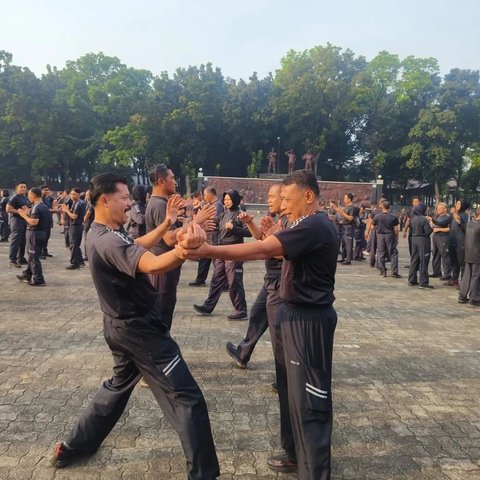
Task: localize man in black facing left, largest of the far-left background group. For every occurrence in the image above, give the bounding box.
[17,187,52,287]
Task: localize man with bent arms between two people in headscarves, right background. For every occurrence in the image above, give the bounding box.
[430,202,452,280]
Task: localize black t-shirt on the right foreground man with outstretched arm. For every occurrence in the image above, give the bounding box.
[275,212,338,306]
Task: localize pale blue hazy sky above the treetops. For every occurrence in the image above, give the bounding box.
[0,0,480,80]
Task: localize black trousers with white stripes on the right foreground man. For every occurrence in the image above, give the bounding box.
[276,304,337,480]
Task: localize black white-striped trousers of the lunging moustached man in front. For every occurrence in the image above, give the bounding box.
[65,308,219,480]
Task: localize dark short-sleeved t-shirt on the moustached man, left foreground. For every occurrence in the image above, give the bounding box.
[87,222,158,319]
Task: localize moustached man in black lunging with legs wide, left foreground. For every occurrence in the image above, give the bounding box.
[51,173,219,480]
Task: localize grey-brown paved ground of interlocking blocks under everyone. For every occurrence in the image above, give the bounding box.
[0,227,480,480]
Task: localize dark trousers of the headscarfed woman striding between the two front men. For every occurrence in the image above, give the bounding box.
[204,260,247,313]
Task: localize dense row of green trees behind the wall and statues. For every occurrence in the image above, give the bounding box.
[0,44,480,202]
